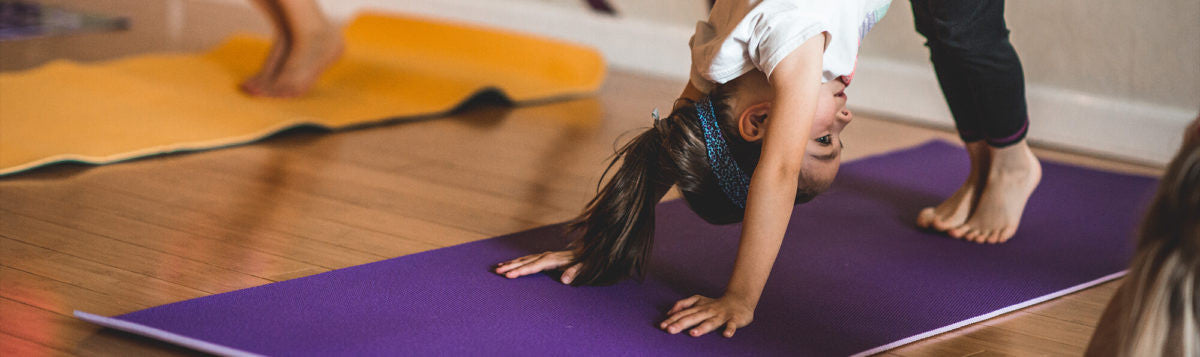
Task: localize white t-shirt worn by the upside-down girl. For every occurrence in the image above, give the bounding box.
[689,0,892,93]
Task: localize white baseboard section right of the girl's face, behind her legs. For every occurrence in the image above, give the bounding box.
[847,59,1196,165]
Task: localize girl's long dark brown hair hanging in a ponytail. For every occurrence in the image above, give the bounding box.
[570,86,757,285]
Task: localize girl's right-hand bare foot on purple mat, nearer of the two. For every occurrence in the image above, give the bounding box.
[949,140,1042,243]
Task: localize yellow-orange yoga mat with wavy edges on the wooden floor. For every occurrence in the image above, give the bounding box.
[0,14,605,175]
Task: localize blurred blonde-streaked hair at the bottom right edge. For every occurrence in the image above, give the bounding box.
[1093,126,1200,357]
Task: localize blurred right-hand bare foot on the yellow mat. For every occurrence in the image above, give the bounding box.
[256,26,344,97]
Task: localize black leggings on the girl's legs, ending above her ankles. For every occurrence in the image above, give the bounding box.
[911,0,1030,147]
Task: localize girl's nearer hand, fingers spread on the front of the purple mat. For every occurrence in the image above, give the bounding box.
[659,295,754,337]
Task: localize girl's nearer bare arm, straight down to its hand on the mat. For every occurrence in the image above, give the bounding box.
[660,36,824,337]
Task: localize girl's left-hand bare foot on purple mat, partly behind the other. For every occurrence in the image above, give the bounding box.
[917,141,990,231]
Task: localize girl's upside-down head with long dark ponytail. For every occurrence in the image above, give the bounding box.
[571,71,852,285]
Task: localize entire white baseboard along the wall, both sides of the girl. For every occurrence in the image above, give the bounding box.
[214,0,1196,165]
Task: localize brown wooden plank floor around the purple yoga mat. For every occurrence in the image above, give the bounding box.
[0,72,1160,356]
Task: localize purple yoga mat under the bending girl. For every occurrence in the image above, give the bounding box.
[77,141,1154,356]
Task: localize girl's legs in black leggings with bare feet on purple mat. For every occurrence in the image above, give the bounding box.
[911,0,1042,243]
